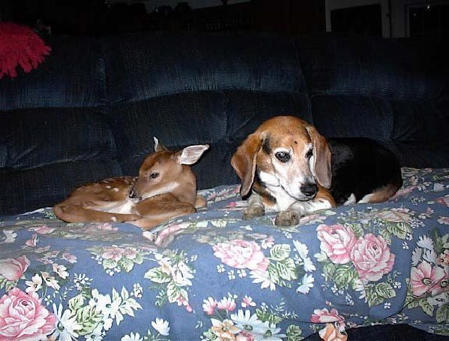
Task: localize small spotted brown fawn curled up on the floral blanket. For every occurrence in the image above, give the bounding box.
[53,138,209,230]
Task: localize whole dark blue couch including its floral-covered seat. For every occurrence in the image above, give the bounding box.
[0,32,449,340]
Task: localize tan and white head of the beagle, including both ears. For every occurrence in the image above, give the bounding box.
[231,116,331,201]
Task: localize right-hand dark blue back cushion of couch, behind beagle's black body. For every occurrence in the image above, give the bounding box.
[297,35,449,167]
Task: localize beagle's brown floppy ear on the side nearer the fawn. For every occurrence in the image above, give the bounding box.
[231,133,263,197]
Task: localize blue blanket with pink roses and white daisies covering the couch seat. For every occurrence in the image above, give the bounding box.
[0,169,449,340]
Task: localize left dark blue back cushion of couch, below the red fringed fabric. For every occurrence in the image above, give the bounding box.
[0,36,121,214]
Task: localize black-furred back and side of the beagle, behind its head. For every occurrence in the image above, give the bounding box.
[328,138,402,205]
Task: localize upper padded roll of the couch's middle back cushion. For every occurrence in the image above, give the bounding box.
[105,32,304,103]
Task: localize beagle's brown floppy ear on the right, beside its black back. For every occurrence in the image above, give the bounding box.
[306,126,332,189]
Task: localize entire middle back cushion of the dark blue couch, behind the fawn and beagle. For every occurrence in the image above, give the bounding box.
[105,32,311,188]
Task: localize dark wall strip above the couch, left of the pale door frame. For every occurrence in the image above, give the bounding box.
[0,0,325,36]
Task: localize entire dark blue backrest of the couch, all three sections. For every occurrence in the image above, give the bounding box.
[0,32,449,214]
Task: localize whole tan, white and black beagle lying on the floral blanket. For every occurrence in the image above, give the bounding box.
[231,116,402,226]
